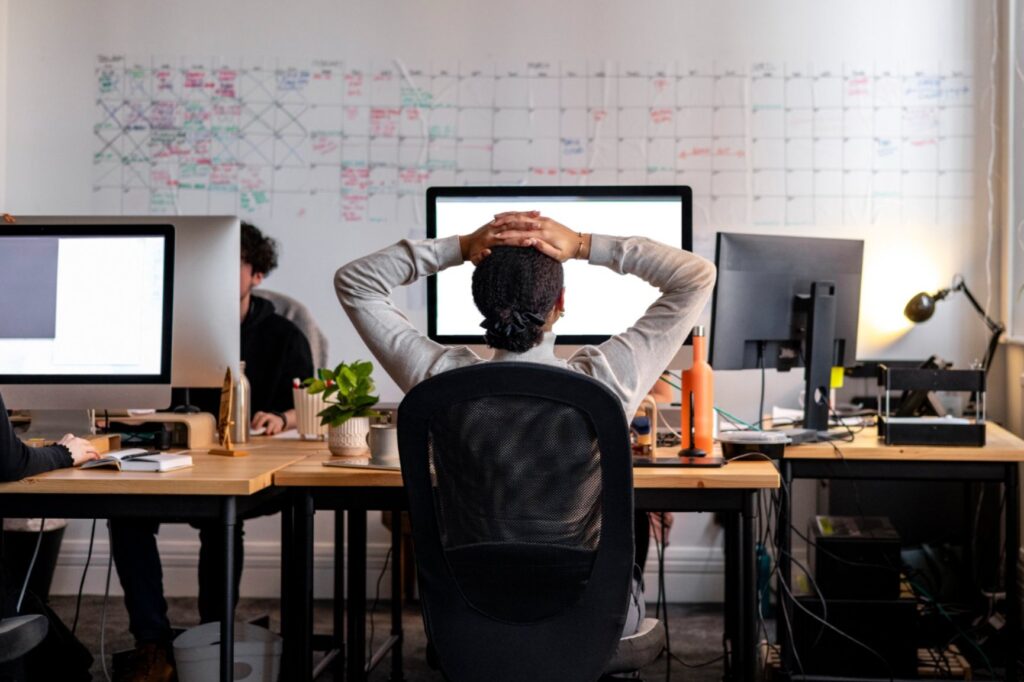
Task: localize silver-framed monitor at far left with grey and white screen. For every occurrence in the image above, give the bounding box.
[0,224,174,435]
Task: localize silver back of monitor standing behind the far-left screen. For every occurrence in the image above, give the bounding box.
[12,216,242,391]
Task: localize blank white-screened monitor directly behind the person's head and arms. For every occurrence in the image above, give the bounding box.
[427,185,693,345]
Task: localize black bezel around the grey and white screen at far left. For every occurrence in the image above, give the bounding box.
[0,224,174,386]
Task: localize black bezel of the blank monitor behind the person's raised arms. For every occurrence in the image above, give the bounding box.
[427,184,693,345]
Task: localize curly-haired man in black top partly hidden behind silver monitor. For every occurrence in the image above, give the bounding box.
[110,222,313,682]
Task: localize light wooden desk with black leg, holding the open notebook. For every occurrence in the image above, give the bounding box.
[0,441,311,682]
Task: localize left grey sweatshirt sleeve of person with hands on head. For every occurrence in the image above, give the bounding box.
[334,237,479,392]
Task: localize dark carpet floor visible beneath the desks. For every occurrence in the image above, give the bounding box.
[50,596,737,682]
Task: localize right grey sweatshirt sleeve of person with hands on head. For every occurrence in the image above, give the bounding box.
[569,235,715,417]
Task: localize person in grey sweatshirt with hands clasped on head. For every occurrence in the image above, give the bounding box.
[335,211,715,634]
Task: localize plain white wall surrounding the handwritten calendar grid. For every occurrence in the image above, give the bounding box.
[0,0,992,601]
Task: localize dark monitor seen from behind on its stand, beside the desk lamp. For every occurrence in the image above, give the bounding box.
[710,232,864,435]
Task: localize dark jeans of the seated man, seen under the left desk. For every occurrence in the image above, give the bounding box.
[110,519,244,643]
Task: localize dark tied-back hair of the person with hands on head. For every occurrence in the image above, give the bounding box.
[473,247,563,353]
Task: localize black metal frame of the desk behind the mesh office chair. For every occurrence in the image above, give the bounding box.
[283,485,761,682]
